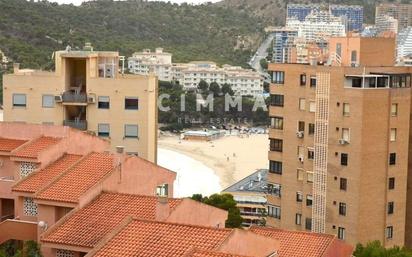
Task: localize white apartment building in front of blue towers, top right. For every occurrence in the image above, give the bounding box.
[286,10,346,42]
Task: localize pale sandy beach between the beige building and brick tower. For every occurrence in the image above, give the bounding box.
[158,134,269,189]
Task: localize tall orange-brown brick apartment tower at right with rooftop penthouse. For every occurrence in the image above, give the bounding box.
[267,38,412,246]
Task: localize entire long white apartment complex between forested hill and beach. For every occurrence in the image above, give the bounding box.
[128,48,263,96]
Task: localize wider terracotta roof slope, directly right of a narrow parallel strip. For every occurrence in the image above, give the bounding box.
[35,153,114,203]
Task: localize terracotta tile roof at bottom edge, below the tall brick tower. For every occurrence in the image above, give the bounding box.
[249,226,336,257]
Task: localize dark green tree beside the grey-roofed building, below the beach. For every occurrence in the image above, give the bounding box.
[192,194,243,228]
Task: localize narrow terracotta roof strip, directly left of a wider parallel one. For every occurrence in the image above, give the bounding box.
[12,154,82,193]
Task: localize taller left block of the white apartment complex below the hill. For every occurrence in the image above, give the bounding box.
[128,48,173,81]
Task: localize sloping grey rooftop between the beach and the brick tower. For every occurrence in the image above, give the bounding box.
[223,169,268,193]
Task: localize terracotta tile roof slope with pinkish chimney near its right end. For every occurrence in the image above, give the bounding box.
[42,193,182,247]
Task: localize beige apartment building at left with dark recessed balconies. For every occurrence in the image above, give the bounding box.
[3,44,158,162]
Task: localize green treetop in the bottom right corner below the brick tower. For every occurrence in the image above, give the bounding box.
[353,241,412,257]
